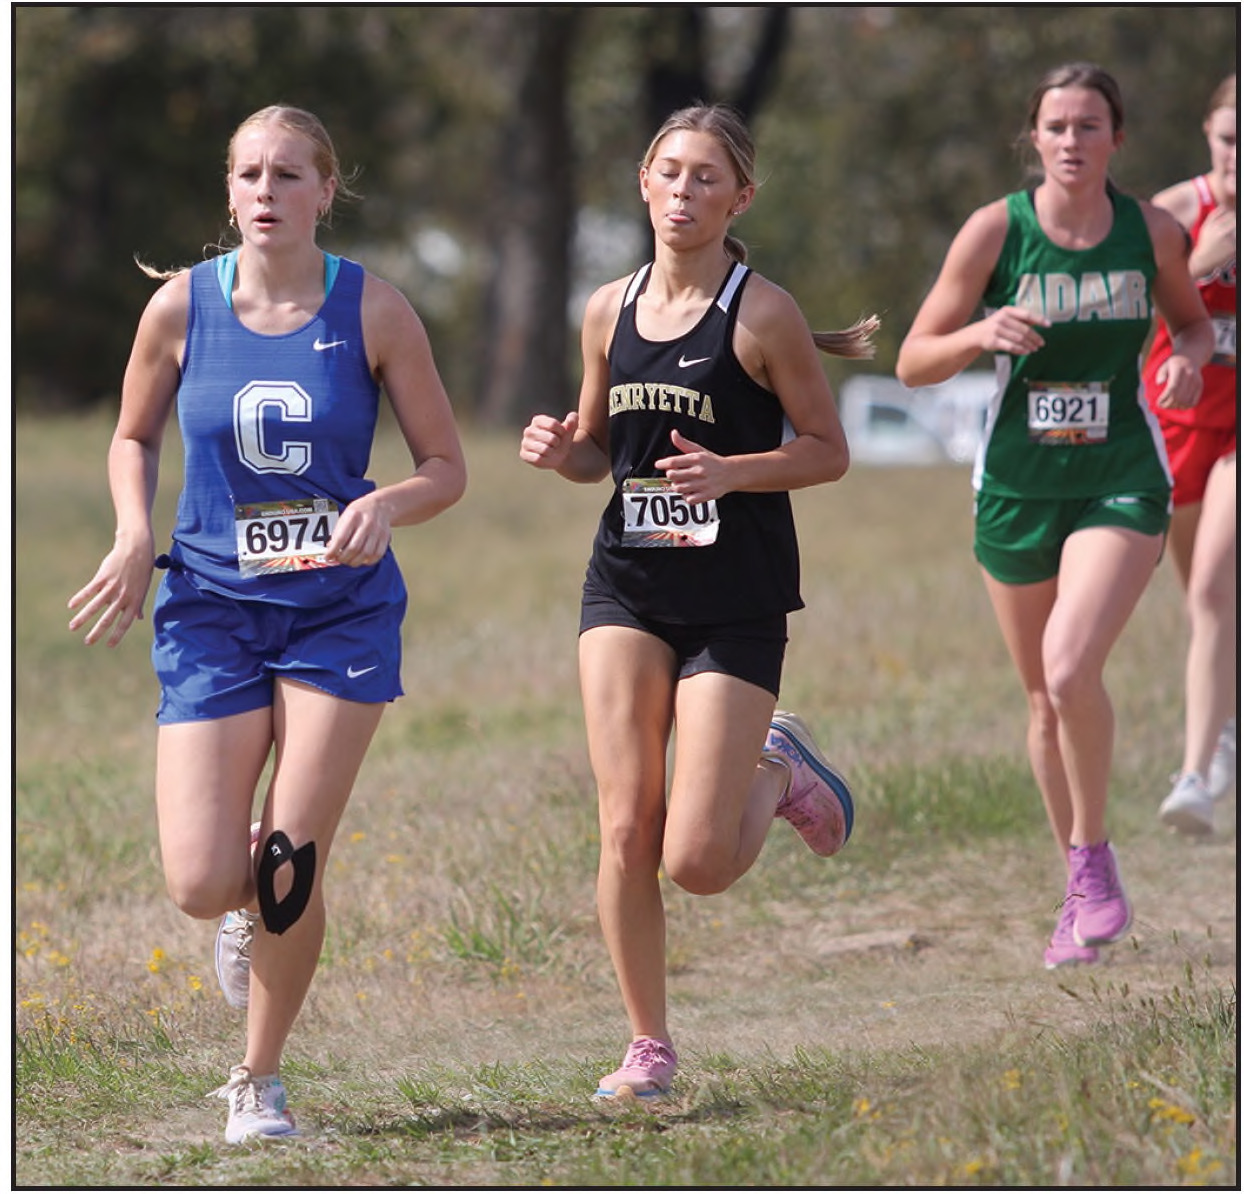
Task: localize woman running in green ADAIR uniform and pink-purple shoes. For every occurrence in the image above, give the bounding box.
[897,62,1214,969]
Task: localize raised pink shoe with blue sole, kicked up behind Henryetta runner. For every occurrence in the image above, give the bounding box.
[761,710,855,858]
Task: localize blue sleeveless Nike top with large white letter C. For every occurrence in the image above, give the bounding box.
[169,251,406,606]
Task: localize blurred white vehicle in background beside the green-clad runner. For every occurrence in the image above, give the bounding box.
[838,369,998,464]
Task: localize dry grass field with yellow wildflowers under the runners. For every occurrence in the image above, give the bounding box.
[14,419,1238,1187]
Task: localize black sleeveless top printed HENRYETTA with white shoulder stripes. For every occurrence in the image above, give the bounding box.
[587,264,804,624]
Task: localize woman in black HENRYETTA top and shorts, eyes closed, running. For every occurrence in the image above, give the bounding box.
[520,106,876,1098]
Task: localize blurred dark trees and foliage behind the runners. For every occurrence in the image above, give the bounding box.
[12,4,1239,425]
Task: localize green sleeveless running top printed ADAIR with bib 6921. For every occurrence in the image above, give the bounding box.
[973,188,1171,499]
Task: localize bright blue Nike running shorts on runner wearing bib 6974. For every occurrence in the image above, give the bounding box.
[152,566,406,725]
